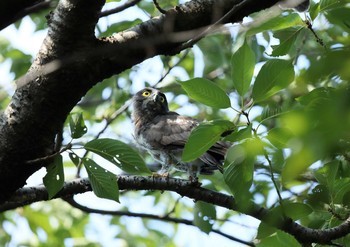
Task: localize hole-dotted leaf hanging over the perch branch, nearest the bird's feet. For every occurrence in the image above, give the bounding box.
[83,159,119,202]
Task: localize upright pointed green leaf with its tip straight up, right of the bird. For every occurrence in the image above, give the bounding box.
[231,41,255,97]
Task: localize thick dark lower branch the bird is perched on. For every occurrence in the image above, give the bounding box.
[0,176,350,244]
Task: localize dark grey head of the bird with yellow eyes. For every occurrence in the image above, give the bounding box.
[134,88,169,115]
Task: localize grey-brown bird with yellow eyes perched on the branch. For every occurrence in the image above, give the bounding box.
[133,88,230,180]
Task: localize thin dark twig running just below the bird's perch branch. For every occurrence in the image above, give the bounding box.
[64,197,255,246]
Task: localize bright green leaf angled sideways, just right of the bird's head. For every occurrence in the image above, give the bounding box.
[180,78,231,108]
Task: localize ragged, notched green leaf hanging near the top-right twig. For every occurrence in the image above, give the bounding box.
[270,27,303,57]
